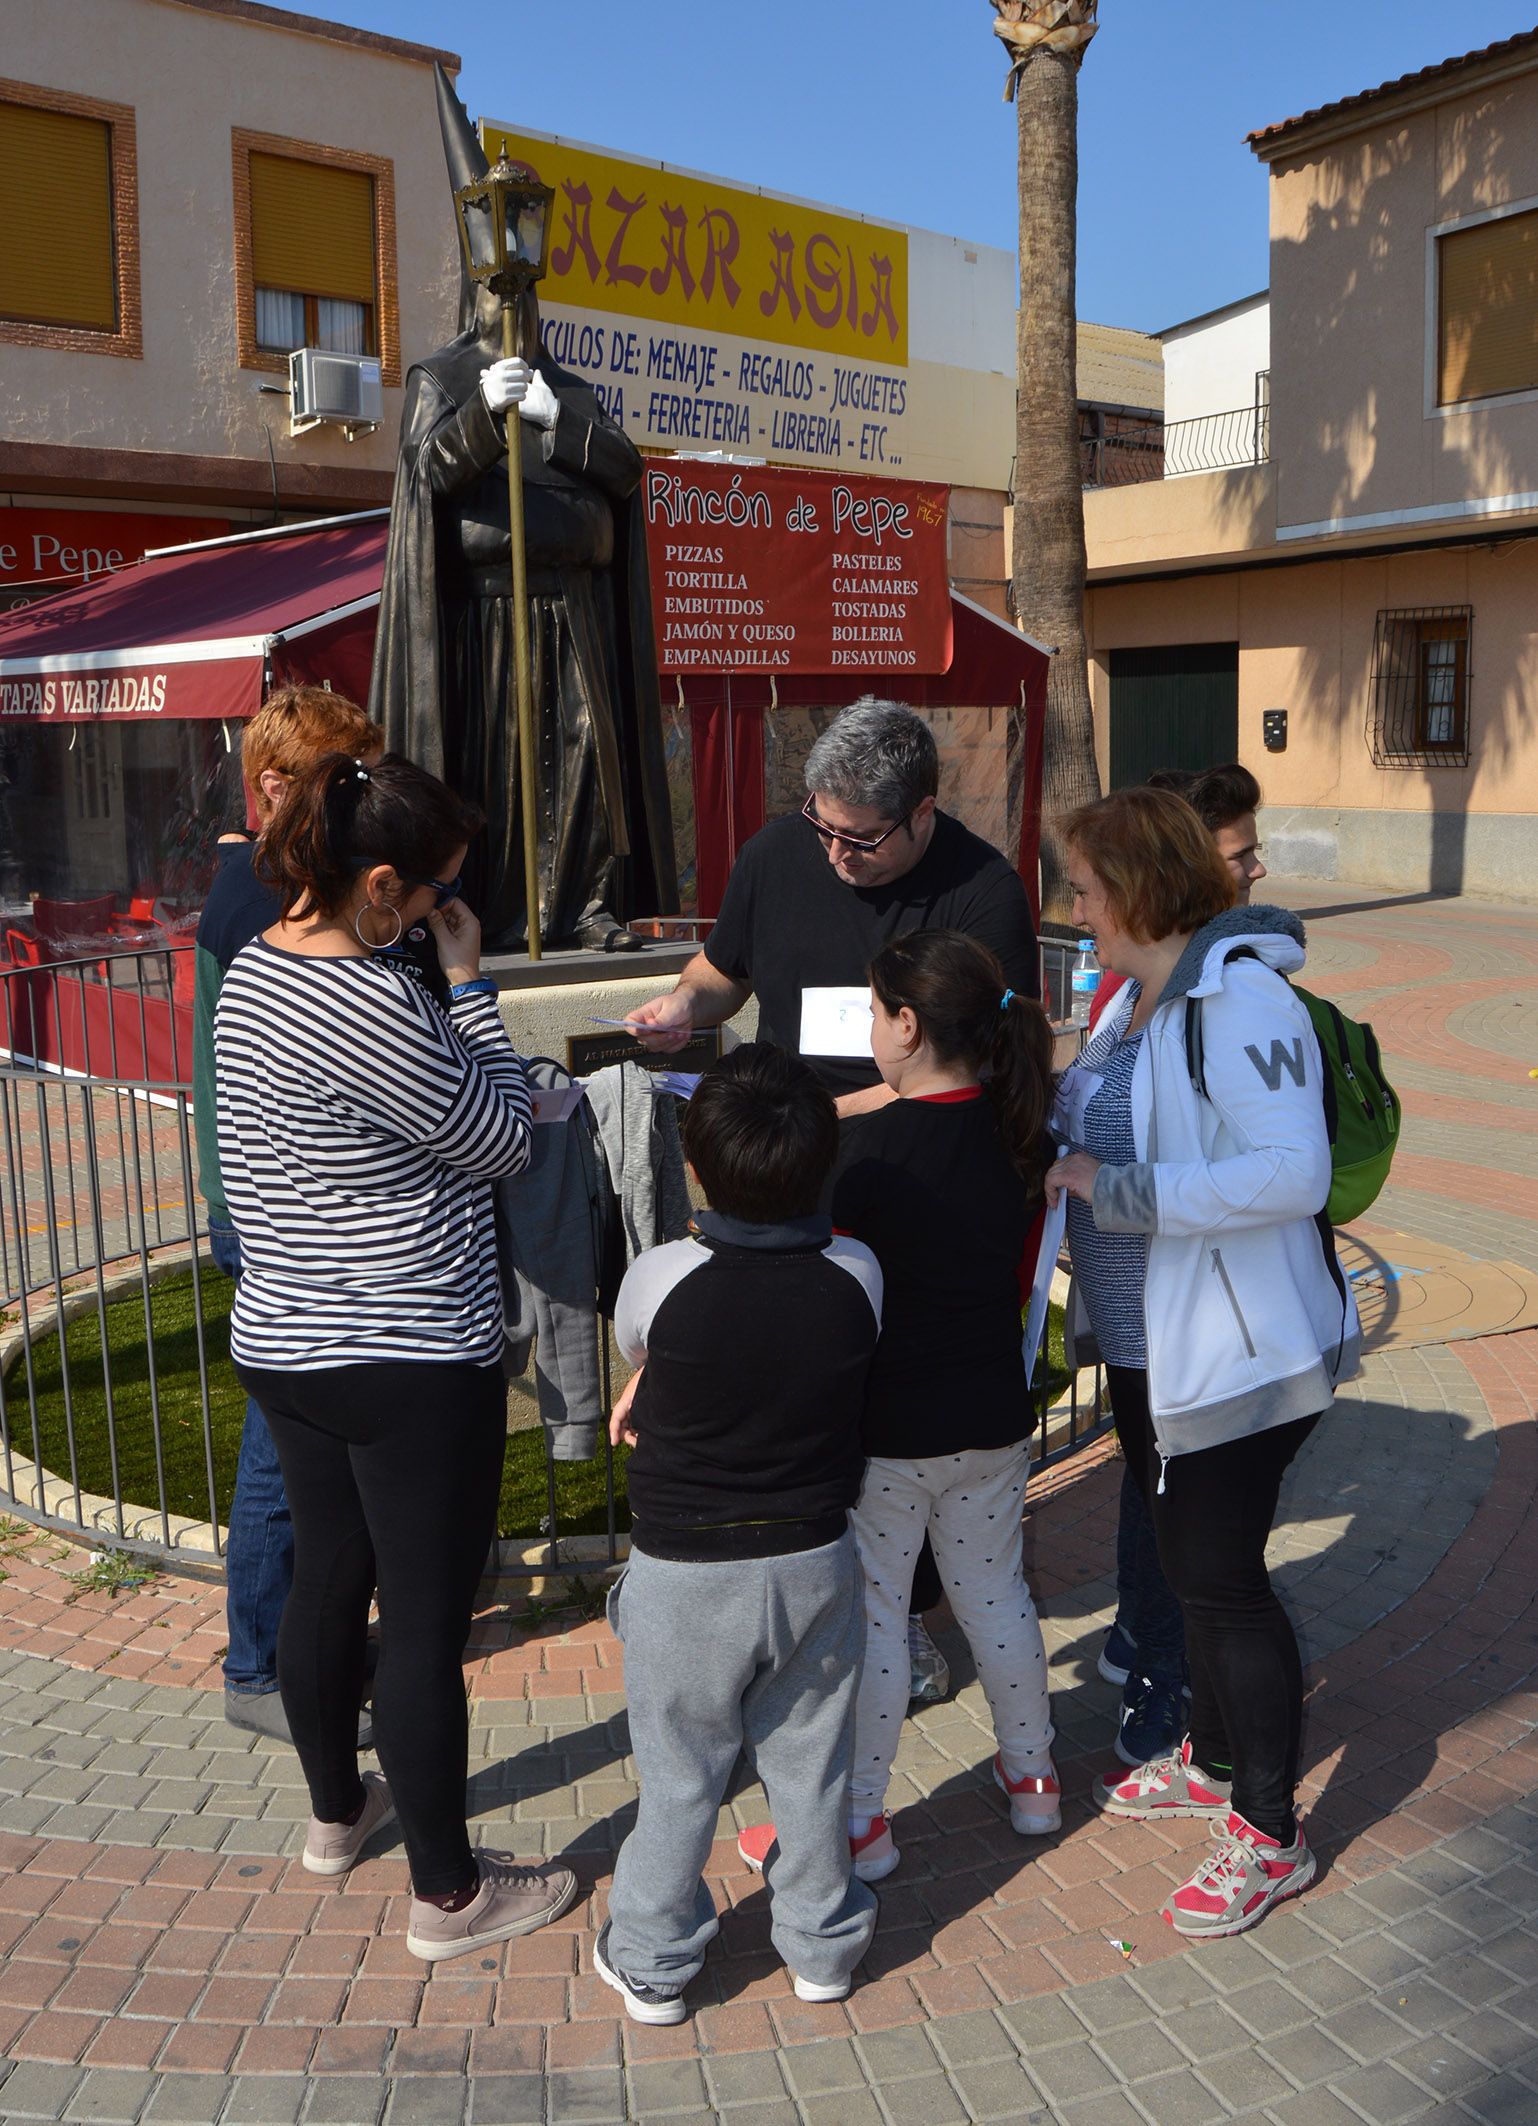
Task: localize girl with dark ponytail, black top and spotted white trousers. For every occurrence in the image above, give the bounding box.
[738,931,1061,1882]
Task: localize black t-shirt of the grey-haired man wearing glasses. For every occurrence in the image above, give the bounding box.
[704,812,1040,1093]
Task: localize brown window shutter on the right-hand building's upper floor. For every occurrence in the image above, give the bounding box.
[1436,213,1538,406]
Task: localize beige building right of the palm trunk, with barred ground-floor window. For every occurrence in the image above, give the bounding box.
[1085,32,1538,897]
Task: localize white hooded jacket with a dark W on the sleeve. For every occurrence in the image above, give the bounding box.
[1057,908,1361,1461]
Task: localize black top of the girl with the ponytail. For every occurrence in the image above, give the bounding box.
[834,1091,1042,1461]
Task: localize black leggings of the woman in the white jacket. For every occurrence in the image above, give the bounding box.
[1106,1365,1319,1845]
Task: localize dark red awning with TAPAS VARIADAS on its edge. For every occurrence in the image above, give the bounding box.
[0,510,389,723]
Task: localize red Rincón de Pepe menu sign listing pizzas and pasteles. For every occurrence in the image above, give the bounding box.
[645,457,951,674]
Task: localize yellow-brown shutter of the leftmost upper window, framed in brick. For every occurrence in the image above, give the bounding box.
[0,102,117,332]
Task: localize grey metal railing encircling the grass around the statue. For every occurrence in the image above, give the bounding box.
[0,940,1108,1577]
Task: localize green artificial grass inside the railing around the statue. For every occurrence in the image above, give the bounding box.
[6,1269,1068,1541]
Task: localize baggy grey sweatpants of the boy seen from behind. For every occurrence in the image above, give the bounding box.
[606,1535,876,1986]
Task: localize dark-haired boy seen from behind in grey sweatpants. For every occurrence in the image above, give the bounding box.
[594,1042,881,2024]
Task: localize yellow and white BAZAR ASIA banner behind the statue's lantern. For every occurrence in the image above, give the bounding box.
[481,119,910,472]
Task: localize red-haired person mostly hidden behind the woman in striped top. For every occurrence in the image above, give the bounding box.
[191,687,385,1748]
